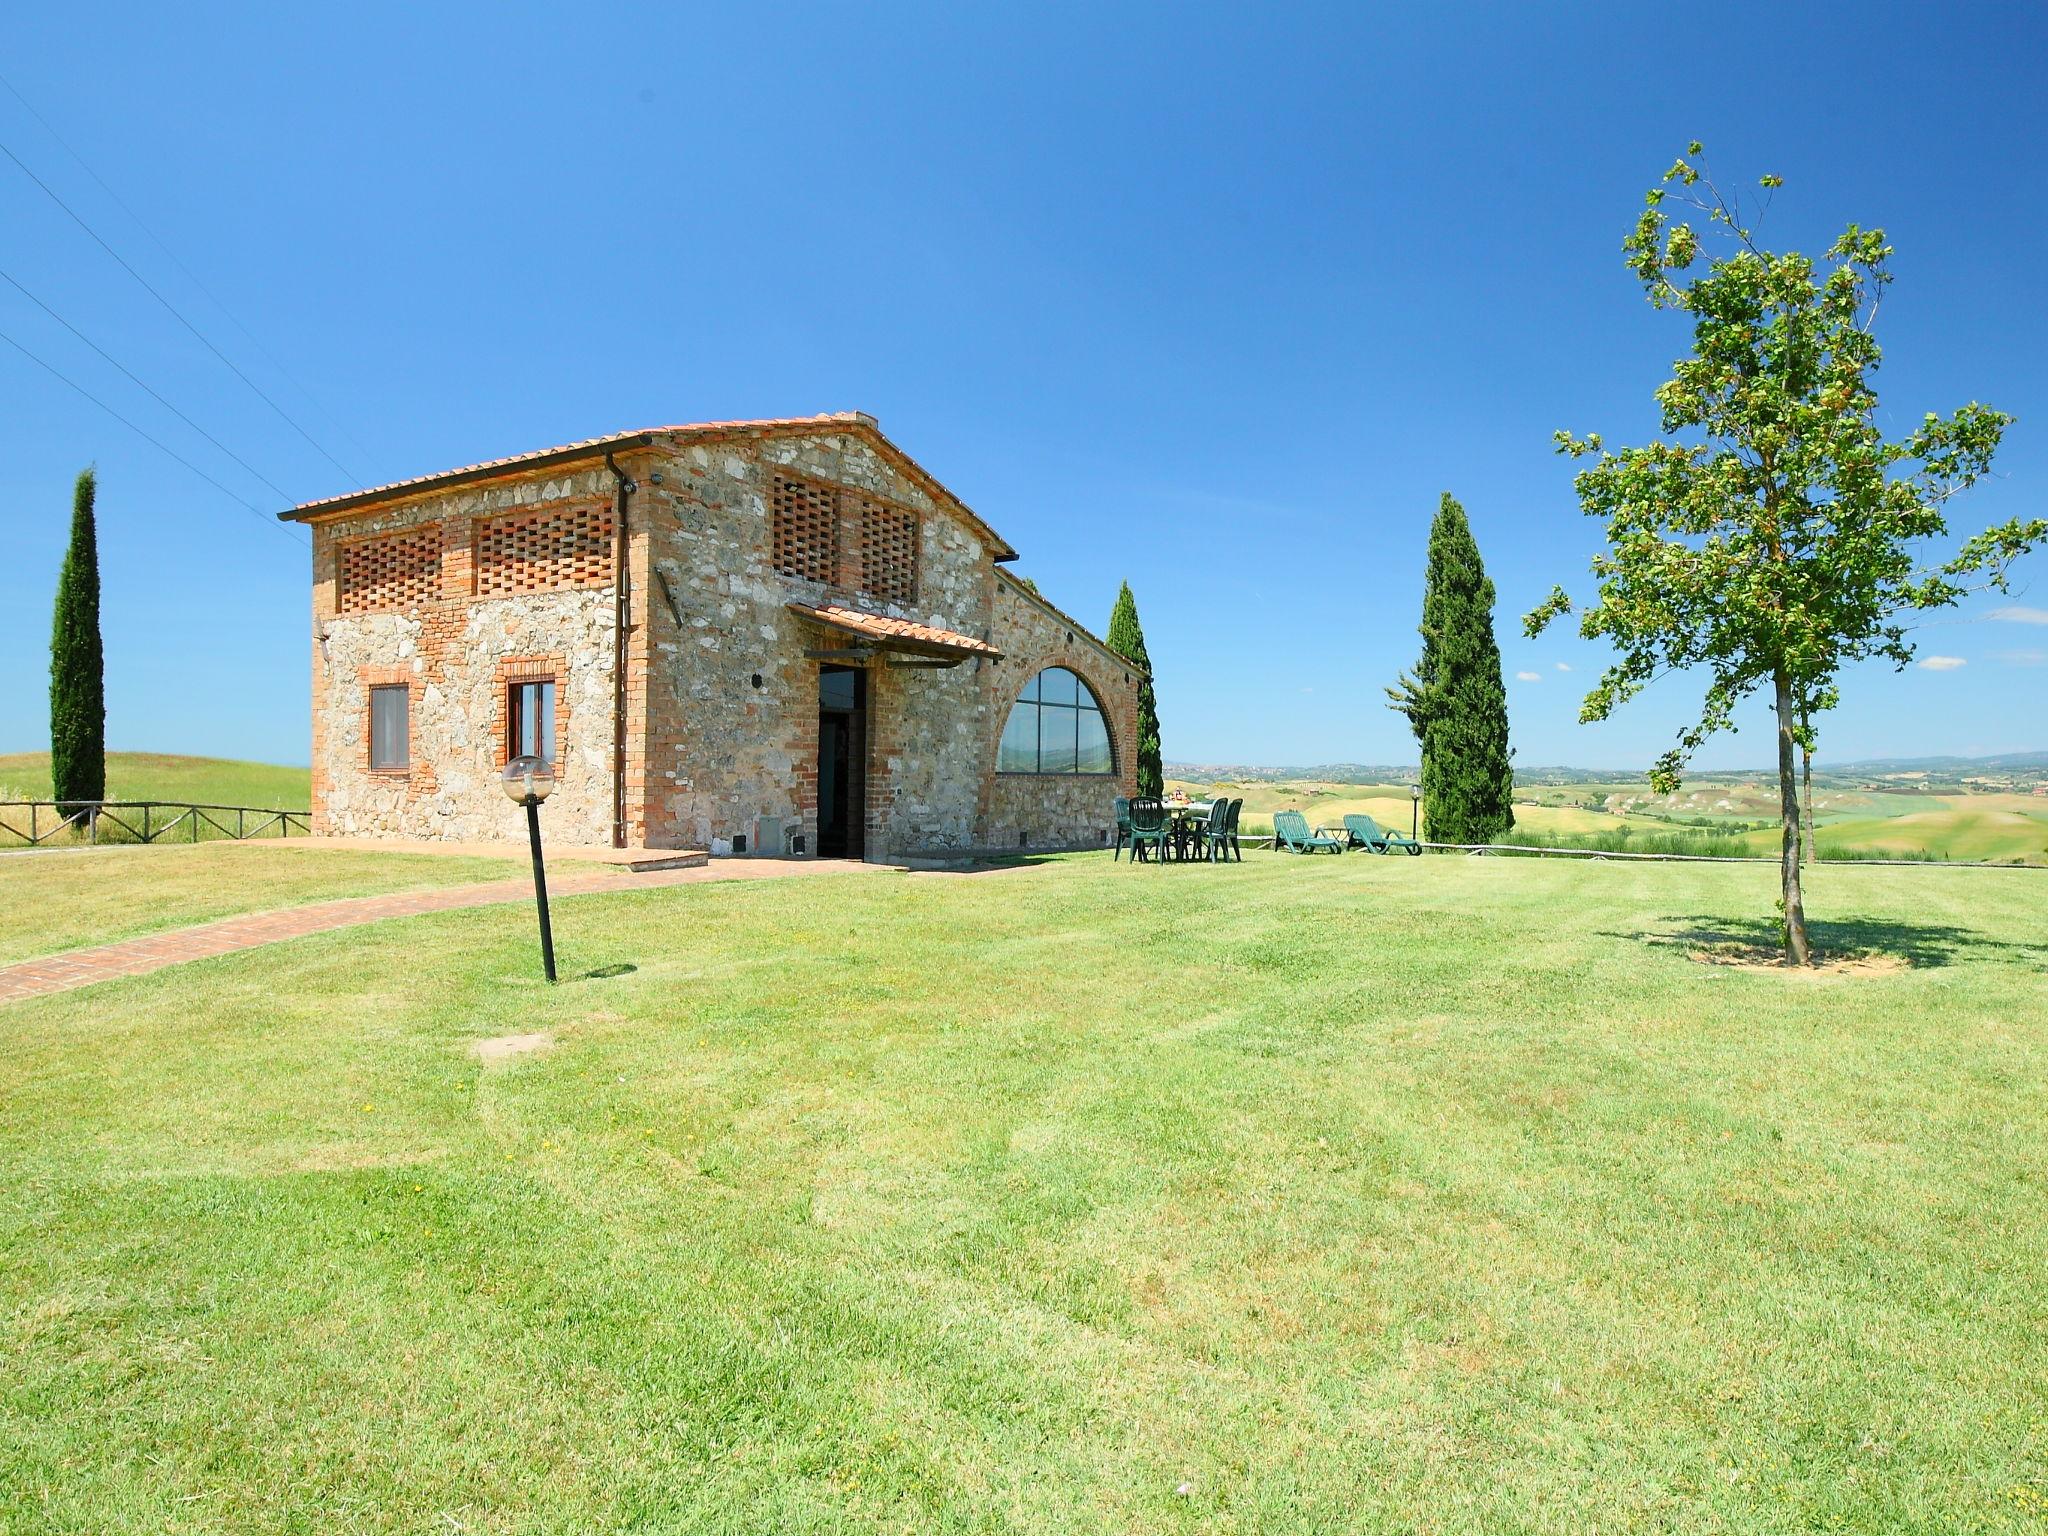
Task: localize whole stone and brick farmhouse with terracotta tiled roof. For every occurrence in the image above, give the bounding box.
[281,412,1139,860]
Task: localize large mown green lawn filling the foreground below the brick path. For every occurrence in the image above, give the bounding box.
[0,850,2048,1536]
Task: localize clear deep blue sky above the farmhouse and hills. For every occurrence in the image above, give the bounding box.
[0,4,2048,766]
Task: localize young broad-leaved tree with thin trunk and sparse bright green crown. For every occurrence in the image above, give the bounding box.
[1526,143,2048,965]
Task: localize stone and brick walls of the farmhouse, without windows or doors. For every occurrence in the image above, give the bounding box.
[301,426,1137,858]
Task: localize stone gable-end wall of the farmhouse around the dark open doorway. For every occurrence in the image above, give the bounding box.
[635,432,991,858]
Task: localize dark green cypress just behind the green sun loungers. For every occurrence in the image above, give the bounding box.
[1386,492,1516,842]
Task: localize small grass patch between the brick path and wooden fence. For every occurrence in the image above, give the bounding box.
[0,840,526,962]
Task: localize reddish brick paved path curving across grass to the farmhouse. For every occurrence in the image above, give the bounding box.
[0,860,874,1004]
